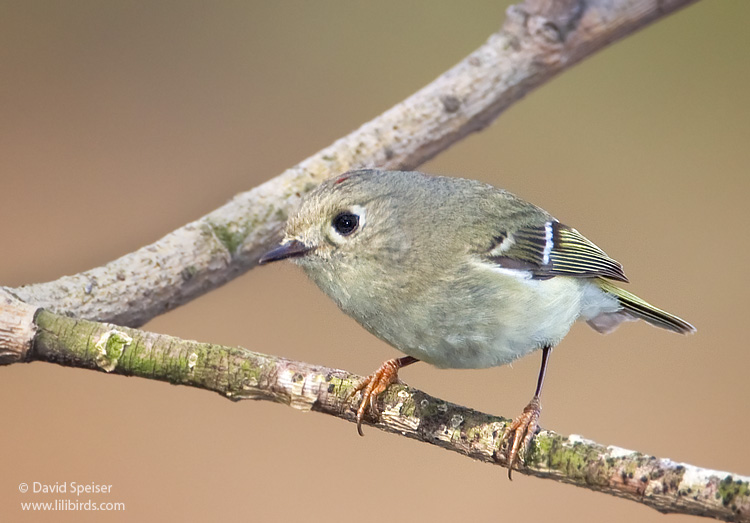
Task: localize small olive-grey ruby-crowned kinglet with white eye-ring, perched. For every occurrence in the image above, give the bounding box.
[260,170,695,476]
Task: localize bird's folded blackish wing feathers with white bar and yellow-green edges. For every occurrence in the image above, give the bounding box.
[484,223,628,282]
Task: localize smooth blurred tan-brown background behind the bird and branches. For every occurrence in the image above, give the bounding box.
[0,0,750,522]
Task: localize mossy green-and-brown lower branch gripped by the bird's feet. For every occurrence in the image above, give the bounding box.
[0,292,750,521]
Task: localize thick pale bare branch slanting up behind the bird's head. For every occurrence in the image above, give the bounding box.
[4,0,695,326]
